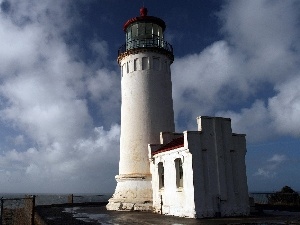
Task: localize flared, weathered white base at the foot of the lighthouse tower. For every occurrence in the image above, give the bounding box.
[106,174,153,211]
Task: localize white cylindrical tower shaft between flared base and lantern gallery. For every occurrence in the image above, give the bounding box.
[119,52,175,174]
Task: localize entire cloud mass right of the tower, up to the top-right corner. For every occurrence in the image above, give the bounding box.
[173,1,300,143]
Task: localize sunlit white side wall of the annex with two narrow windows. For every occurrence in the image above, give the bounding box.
[151,144,195,218]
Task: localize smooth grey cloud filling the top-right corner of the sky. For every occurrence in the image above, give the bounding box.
[221,1,299,82]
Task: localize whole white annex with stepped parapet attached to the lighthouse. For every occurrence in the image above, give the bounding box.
[149,117,249,218]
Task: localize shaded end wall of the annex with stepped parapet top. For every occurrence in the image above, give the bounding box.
[191,117,249,217]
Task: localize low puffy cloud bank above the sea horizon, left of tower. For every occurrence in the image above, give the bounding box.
[0,125,120,192]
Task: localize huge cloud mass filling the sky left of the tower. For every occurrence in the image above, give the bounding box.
[0,0,120,192]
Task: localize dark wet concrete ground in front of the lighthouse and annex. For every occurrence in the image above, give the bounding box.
[36,203,300,225]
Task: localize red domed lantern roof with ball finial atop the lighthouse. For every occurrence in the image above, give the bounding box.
[123,7,166,31]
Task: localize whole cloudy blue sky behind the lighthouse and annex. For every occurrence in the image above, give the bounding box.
[0,0,300,193]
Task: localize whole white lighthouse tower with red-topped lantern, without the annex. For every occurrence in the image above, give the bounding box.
[107,7,175,210]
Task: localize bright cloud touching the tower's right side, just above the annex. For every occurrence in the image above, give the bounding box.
[172,41,252,129]
